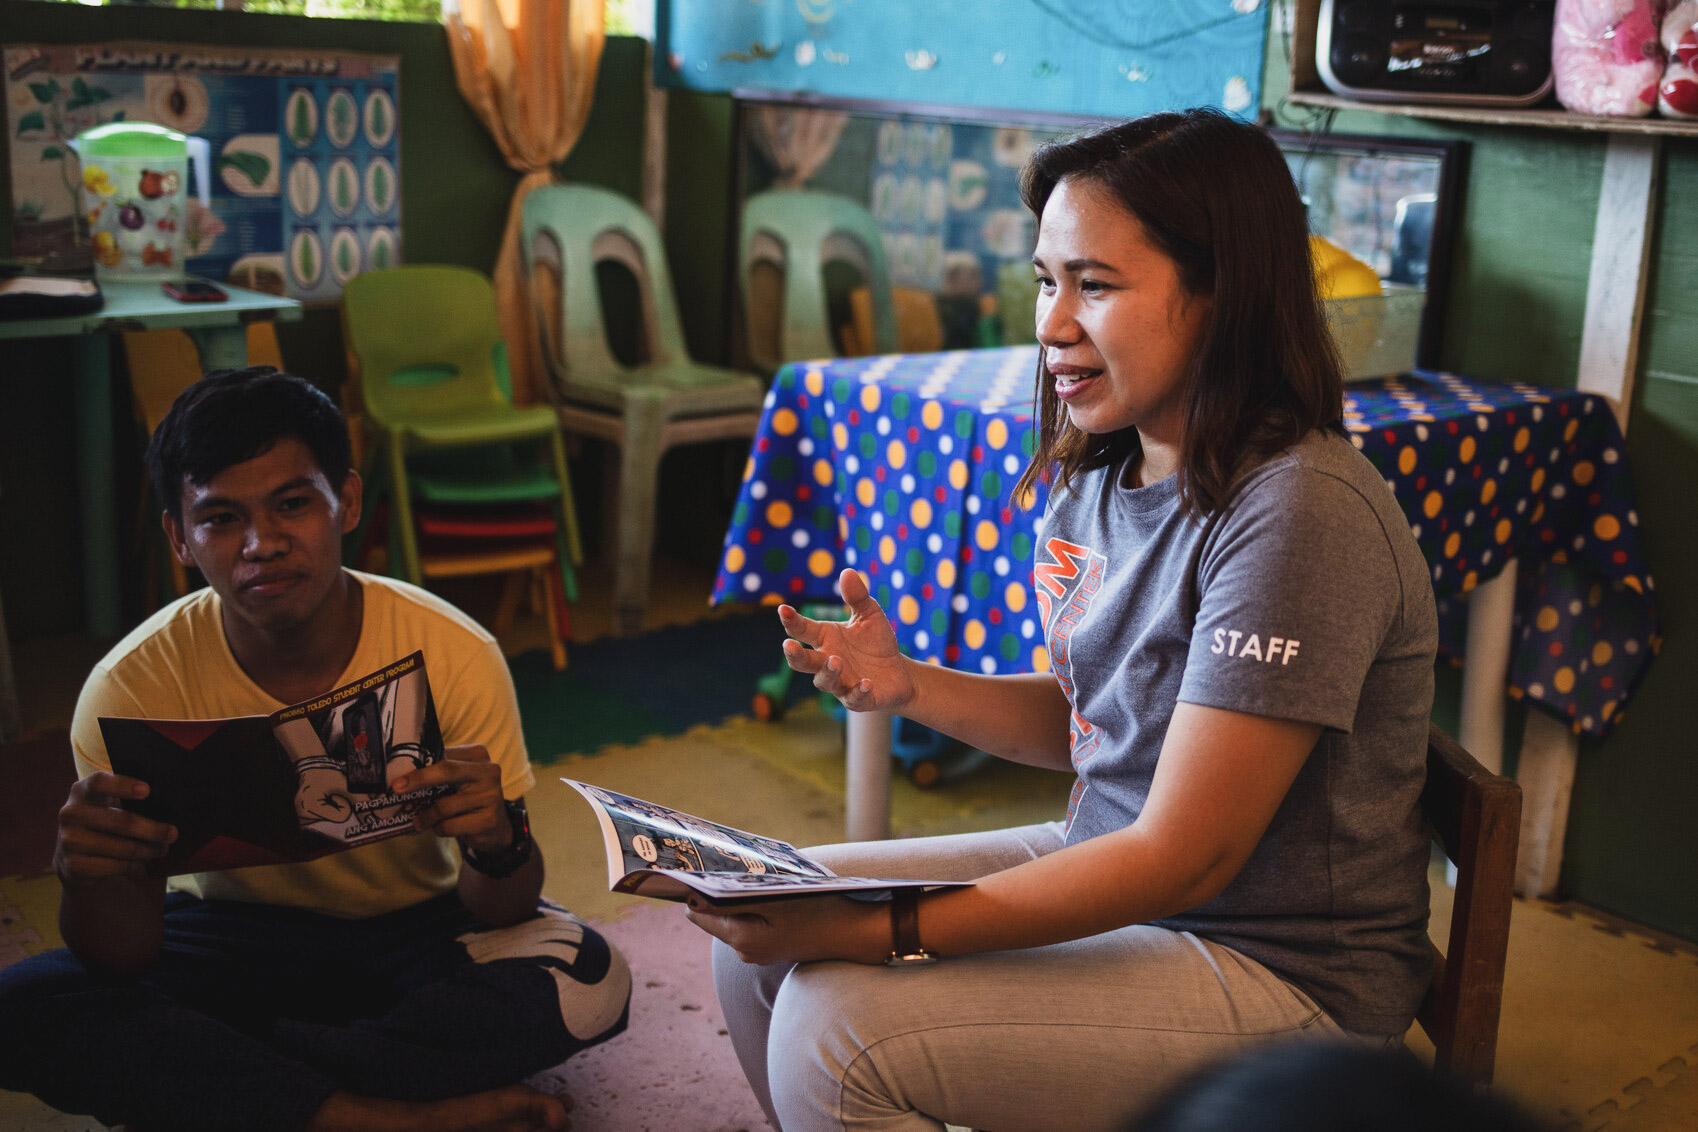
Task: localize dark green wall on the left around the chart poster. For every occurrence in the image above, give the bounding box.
[0,0,647,638]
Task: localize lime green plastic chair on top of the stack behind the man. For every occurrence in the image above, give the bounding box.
[341,265,582,601]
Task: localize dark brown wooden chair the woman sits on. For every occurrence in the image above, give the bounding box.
[1416,725,1521,1084]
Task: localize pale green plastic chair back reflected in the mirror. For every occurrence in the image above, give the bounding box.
[737,188,898,375]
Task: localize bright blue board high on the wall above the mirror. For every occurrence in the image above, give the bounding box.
[655,0,1267,119]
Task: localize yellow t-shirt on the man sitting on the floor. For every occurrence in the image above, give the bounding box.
[71,570,537,918]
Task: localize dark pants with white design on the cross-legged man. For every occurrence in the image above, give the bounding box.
[0,893,630,1132]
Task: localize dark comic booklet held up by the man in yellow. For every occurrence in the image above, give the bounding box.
[100,652,448,876]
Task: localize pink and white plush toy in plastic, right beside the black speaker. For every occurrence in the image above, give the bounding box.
[1550,0,1664,117]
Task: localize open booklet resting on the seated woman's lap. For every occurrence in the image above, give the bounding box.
[560,779,971,901]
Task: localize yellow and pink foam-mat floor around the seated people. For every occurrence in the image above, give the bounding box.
[0,560,1698,1132]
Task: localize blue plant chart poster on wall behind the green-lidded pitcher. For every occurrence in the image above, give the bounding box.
[5,42,401,302]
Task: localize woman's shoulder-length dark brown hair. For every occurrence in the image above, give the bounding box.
[1015,109,1343,514]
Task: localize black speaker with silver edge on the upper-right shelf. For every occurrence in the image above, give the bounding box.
[1314,0,1555,107]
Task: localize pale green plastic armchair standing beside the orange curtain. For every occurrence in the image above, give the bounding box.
[523,185,766,636]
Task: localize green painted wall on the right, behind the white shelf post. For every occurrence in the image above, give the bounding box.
[1263,36,1698,939]
